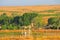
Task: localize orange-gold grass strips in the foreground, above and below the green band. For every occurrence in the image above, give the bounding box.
[0,29,60,40]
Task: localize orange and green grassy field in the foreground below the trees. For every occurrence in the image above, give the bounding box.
[0,29,60,40]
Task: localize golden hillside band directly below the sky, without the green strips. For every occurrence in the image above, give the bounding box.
[0,5,60,15]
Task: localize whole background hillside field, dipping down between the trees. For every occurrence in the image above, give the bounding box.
[0,5,60,23]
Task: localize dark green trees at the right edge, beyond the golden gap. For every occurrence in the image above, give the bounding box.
[46,17,60,29]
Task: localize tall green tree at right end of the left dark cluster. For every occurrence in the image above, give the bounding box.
[22,13,38,26]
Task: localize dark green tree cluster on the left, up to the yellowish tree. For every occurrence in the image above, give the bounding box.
[0,13,37,30]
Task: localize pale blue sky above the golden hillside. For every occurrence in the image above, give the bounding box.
[0,0,60,6]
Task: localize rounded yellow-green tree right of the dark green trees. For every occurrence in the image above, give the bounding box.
[32,15,44,29]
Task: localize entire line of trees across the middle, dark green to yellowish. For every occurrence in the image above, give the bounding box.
[0,12,60,30]
